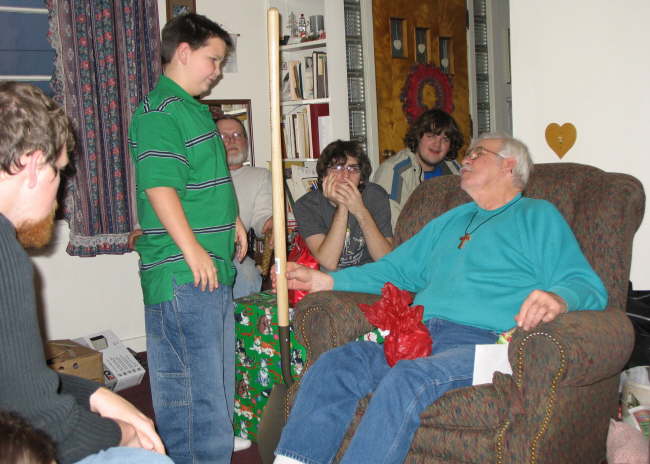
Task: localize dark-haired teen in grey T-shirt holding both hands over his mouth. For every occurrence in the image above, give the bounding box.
[294,140,393,271]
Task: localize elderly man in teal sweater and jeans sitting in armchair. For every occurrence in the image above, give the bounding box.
[275,134,607,464]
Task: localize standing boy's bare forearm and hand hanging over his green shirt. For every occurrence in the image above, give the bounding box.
[145,187,219,291]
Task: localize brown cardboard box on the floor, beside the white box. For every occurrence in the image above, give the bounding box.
[45,340,104,384]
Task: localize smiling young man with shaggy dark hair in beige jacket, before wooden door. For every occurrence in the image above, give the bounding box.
[372,109,463,229]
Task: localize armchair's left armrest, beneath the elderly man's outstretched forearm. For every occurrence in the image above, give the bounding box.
[293,291,380,364]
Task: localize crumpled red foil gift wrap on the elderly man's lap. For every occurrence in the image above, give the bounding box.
[359,282,433,367]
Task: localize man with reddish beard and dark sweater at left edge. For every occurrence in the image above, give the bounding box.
[0,82,171,464]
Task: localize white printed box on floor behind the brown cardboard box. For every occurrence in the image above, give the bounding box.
[74,330,144,391]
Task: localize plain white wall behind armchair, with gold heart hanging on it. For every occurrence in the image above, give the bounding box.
[510,0,650,289]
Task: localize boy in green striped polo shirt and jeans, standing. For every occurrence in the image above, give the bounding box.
[129,14,246,464]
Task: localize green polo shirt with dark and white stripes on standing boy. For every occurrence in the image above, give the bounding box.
[129,76,237,305]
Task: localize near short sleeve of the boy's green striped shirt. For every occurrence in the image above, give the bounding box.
[130,111,190,197]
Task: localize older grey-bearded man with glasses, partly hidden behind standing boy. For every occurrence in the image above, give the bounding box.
[217,116,273,298]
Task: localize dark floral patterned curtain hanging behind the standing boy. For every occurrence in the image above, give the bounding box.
[47,0,161,256]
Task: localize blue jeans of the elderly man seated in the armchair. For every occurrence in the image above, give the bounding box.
[275,319,498,464]
